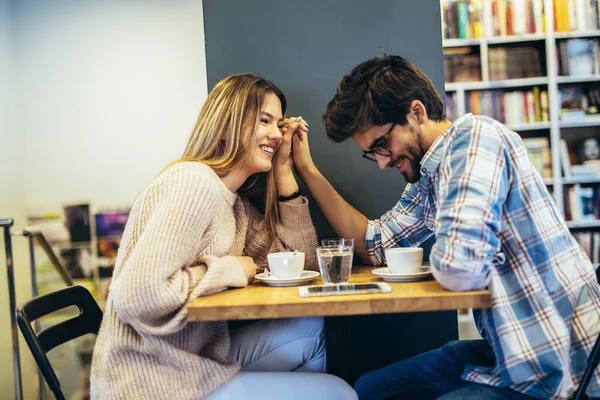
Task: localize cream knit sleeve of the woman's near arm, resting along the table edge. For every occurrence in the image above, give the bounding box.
[110,164,247,335]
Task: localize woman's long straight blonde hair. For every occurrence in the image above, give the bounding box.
[176,74,287,240]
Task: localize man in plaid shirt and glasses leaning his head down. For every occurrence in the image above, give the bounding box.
[293,56,600,399]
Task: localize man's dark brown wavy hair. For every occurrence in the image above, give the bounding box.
[323,55,446,143]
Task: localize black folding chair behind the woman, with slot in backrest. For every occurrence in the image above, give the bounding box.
[16,286,102,400]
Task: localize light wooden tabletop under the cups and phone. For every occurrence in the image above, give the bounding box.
[188,267,491,321]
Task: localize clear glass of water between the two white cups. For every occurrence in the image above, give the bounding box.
[317,245,354,285]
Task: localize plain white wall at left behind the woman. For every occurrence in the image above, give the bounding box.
[0,0,207,399]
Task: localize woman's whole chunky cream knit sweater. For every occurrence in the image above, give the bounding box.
[91,162,317,400]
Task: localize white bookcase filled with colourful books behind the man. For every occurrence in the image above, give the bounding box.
[440,0,600,261]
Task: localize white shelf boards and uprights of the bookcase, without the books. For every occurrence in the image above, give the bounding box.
[442,0,600,229]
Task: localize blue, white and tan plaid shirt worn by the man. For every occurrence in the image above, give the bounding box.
[366,114,600,399]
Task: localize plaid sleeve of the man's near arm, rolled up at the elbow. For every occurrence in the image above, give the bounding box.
[431,119,508,291]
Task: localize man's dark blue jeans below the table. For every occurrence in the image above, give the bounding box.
[354,340,532,400]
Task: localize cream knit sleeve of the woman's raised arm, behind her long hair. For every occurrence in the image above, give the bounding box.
[244,197,319,270]
